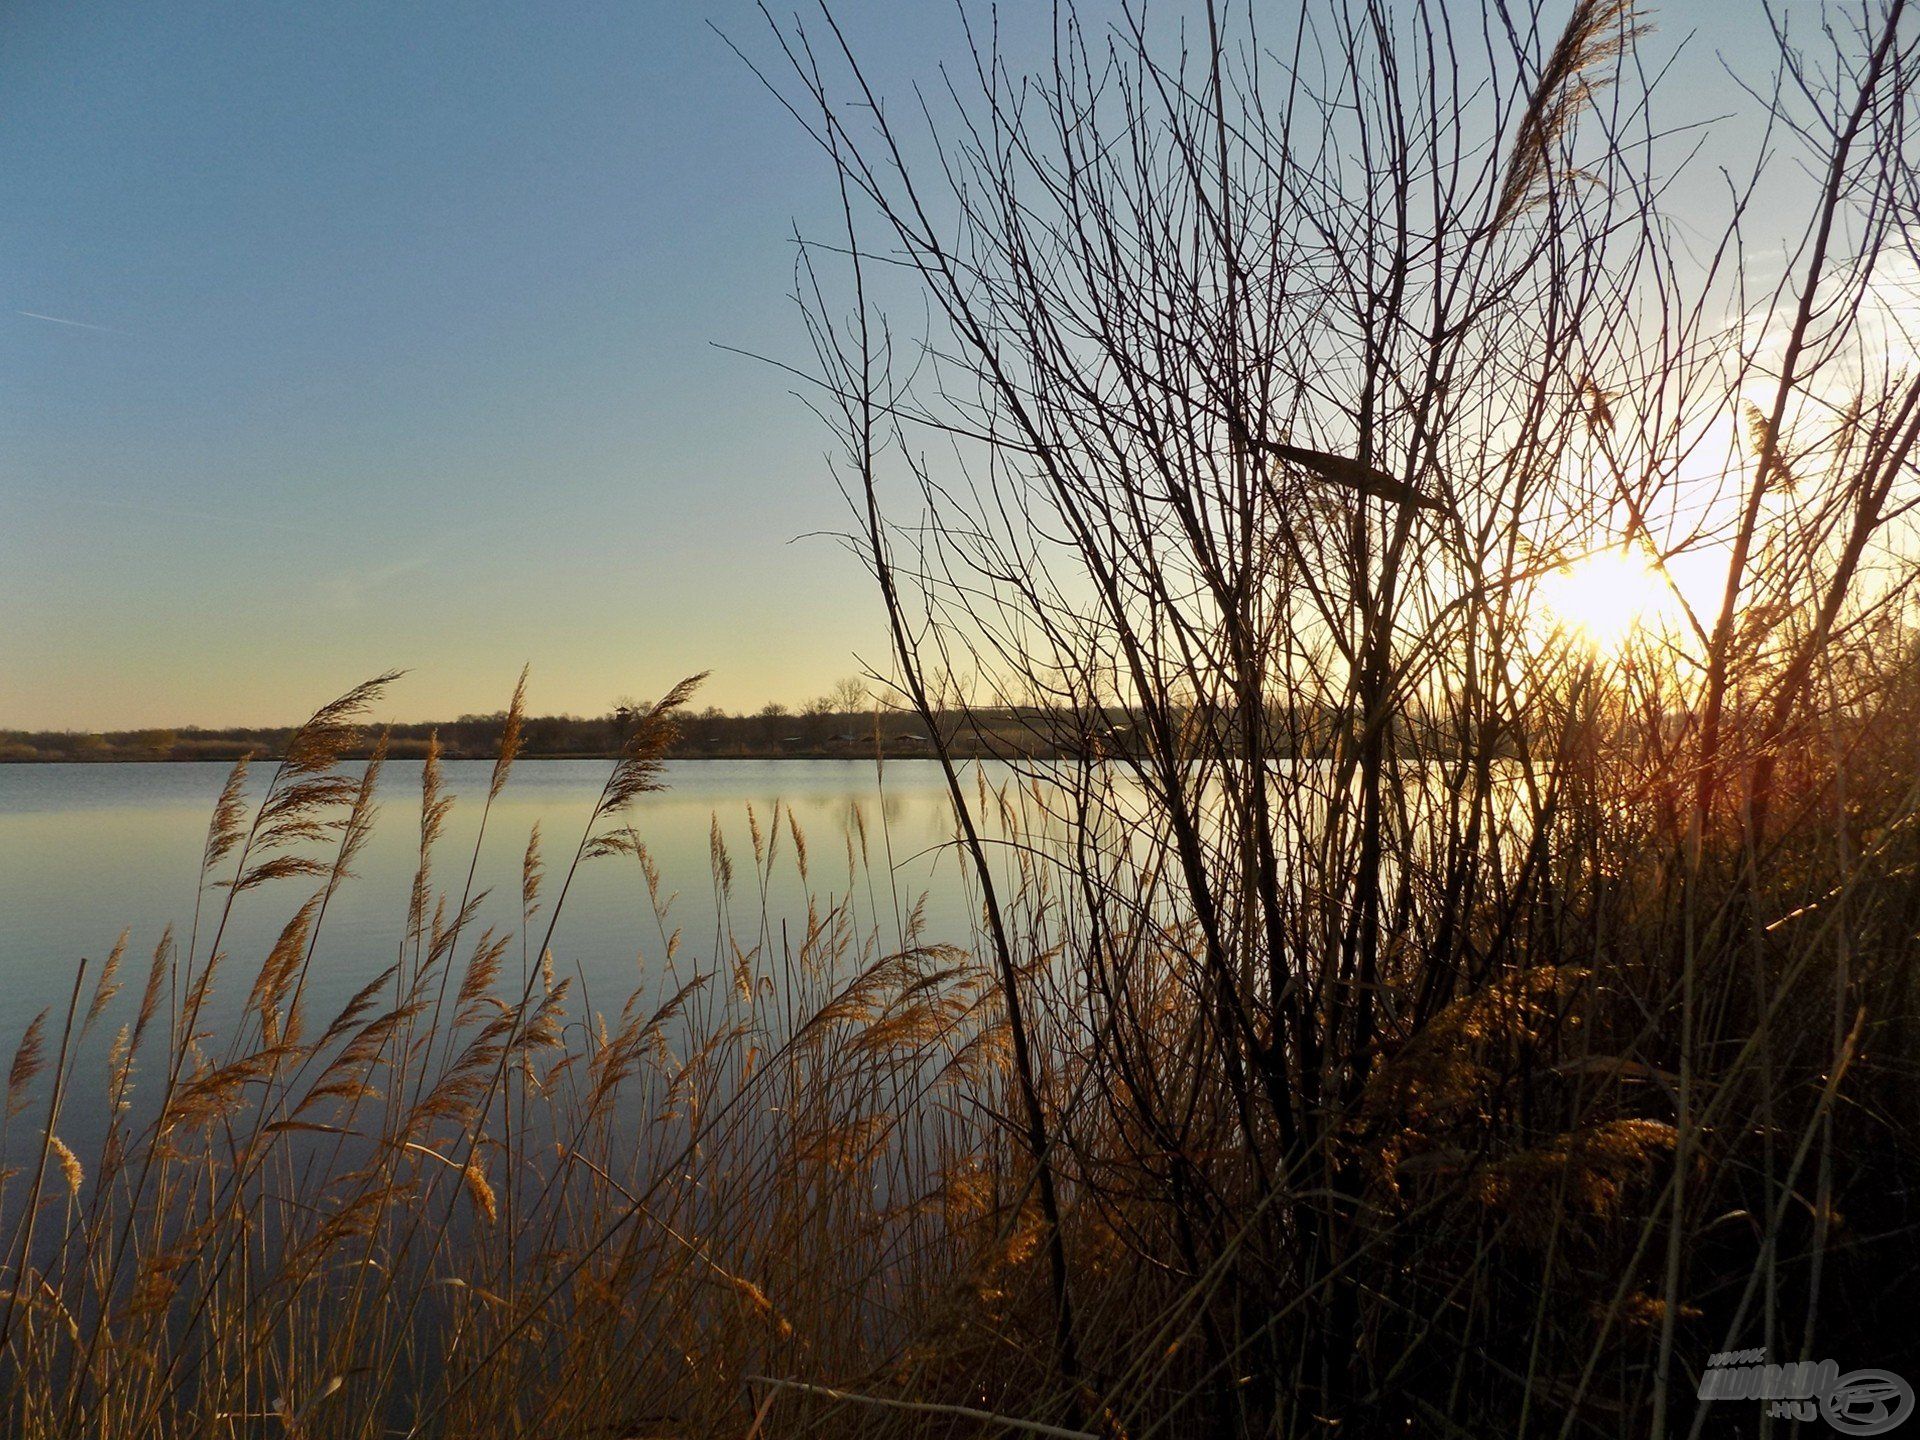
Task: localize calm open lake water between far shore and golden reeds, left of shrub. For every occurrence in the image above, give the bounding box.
[0,760,990,1064]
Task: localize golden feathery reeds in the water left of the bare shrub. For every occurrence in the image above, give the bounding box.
[0,680,1052,1436]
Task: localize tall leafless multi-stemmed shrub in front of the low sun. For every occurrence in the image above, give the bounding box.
[752,0,1920,1432]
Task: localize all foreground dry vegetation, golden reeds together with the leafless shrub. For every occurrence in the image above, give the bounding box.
[0,0,1920,1438]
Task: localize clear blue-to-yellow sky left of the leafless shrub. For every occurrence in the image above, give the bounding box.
[0,0,1781,728]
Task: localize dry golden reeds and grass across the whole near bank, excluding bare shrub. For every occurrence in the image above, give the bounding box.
[0,660,1920,1436]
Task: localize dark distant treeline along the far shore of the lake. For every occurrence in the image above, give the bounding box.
[0,701,1474,764]
